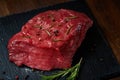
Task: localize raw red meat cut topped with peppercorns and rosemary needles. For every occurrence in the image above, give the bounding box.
[8,9,93,70]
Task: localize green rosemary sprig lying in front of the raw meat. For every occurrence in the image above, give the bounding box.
[41,58,82,80]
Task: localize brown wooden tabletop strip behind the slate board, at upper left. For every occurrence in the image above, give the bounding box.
[0,0,69,16]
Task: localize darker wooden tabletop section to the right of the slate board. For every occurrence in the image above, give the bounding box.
[87,0,120,80]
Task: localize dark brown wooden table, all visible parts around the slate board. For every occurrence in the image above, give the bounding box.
[0,0,120,80]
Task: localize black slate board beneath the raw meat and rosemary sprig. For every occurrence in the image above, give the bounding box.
[0,0,120,80]
